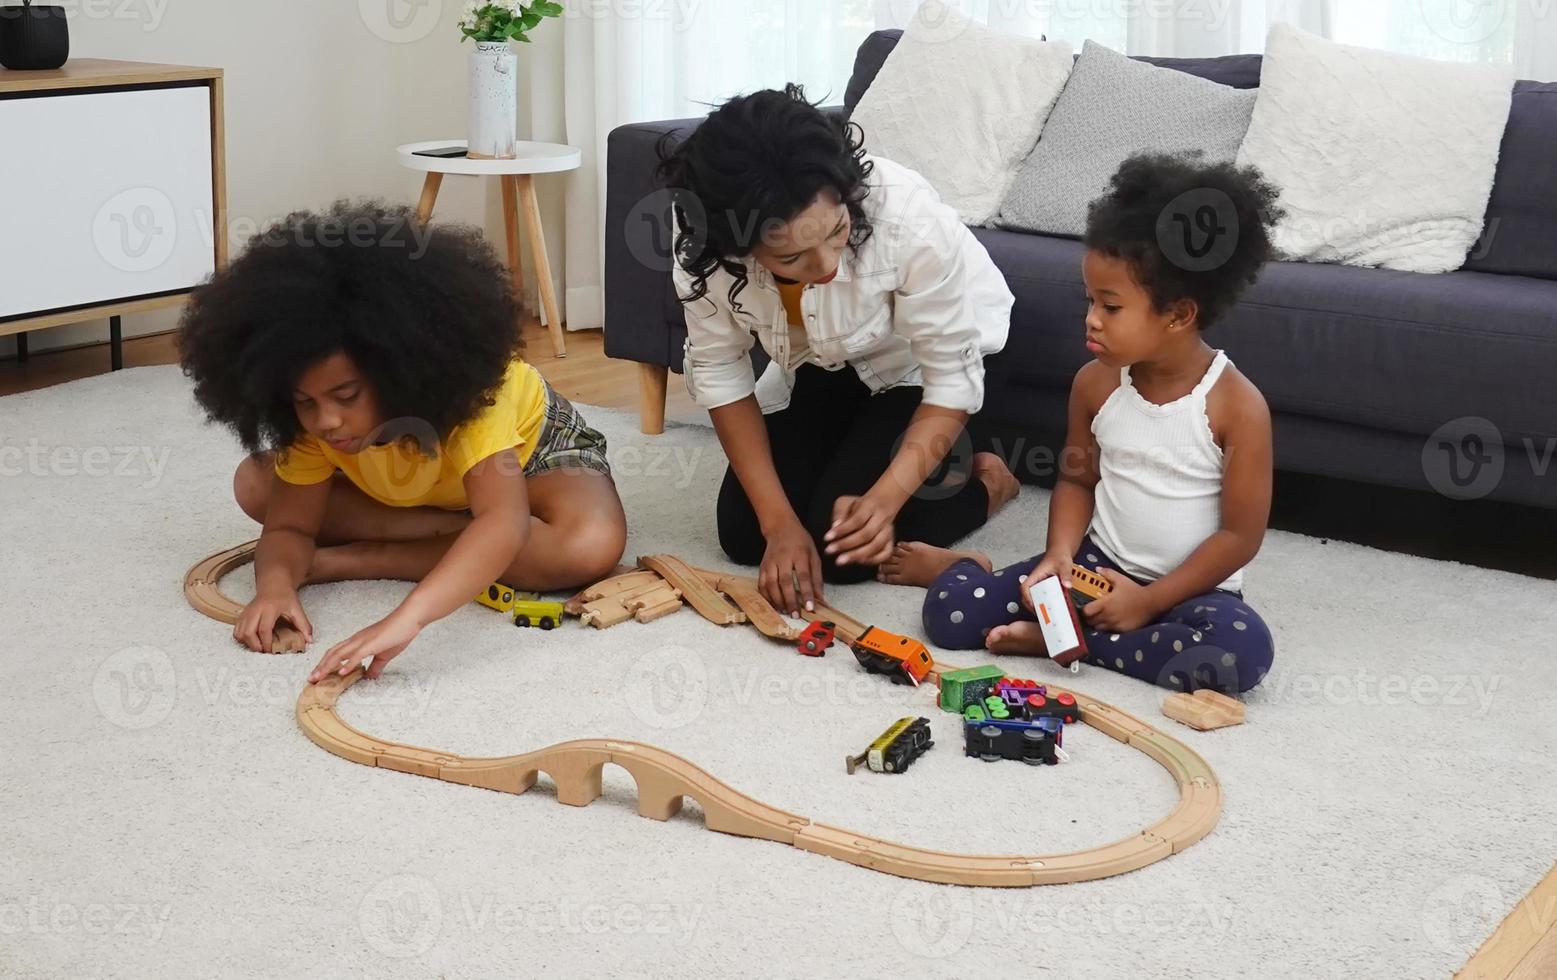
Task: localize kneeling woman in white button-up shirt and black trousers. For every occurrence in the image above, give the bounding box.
[660,86,1018,615]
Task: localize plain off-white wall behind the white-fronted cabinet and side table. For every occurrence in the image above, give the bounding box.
[0,0,571,355]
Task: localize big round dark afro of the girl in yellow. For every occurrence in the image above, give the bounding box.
[179,201,523,452]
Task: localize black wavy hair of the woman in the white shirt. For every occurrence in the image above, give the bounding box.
[655,84,873,310]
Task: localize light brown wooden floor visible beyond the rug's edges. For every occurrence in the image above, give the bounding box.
[0,321,1557,980]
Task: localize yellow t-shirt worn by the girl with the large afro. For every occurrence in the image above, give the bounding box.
[276,360,547,511]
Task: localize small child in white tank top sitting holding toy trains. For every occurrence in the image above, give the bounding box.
[880,157,1281,692]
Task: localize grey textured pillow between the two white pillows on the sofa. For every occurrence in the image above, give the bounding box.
[998,41,1260,238]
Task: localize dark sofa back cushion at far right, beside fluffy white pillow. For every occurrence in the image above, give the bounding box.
[1465,81,1557,279]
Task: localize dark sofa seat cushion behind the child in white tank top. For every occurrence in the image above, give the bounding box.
[975,229,1557,446]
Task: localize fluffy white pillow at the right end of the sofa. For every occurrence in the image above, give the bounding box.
[1238,23,1513,273]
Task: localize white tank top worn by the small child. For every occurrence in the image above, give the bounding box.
[1090,351,1244,592]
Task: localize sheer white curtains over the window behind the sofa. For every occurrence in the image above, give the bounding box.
[541,0,1557,329]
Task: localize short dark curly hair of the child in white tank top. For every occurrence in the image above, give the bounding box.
[1085,154,1286,329]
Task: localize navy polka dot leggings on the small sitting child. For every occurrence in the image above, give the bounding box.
[925,538,1275,693]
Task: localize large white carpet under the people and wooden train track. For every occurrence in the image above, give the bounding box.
[0,368,1557,977]
